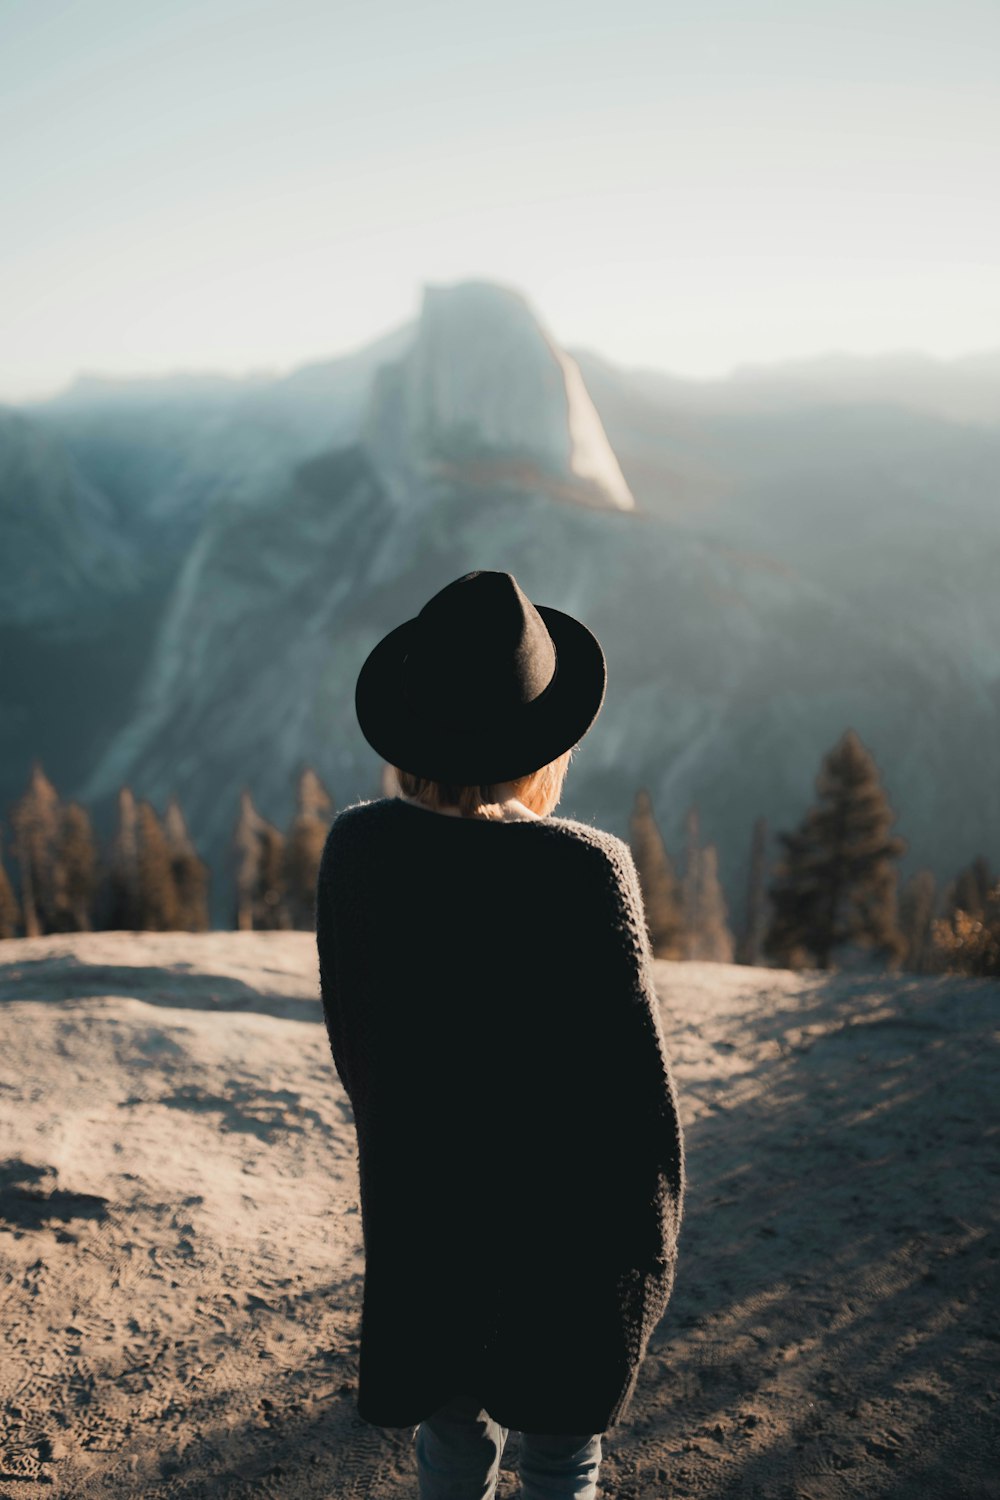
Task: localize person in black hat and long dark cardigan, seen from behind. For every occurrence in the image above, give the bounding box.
[316,569,684,1500]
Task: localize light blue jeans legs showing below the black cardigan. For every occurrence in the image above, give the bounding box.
[414,1397,601,1500]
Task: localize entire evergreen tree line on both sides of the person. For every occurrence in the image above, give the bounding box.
[0,729,1000,975]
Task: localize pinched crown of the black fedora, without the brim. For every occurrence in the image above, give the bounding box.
[402,569,558,725]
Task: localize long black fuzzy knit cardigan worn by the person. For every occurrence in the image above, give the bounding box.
[316,798,684,1434]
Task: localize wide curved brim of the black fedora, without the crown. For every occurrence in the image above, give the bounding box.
[354,605,607,786]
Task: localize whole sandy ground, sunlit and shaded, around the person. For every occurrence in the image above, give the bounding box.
[0,933,1000,1500]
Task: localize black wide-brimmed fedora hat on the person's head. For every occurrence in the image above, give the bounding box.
[354,569,607,786]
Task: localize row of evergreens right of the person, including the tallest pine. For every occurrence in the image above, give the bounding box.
[630,729,1000,975]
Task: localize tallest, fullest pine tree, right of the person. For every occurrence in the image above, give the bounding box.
[765,729,906,969]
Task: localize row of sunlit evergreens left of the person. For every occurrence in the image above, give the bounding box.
[0,761,333,938]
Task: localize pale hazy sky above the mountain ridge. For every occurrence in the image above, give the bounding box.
[0,0,1000,401]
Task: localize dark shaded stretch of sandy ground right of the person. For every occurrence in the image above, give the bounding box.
[634,966,1000,1500]
